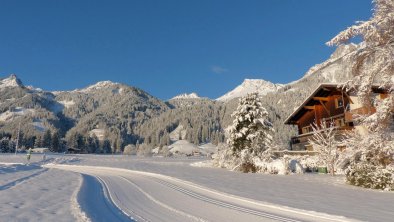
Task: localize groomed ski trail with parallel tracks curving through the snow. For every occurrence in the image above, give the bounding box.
[46,164,355,222]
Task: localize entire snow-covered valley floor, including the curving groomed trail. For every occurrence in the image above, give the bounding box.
[0,154,394,221]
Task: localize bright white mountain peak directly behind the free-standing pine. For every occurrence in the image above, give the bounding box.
[216,79,283,102]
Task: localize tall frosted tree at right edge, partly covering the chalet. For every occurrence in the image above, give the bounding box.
[327,0,394,189]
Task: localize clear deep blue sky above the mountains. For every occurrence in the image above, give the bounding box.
[0,0,372,99]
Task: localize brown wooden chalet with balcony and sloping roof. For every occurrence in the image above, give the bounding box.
[285,83,387,151]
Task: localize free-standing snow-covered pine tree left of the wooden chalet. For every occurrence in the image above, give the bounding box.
[227,93,273,172]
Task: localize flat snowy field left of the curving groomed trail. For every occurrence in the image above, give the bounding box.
[0,156,82,221]
